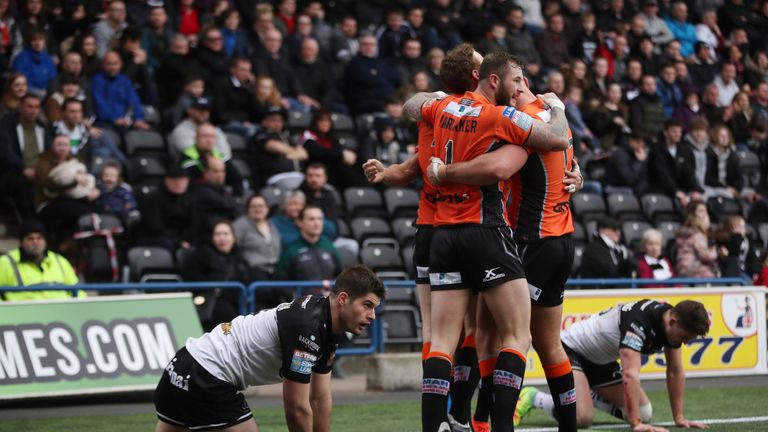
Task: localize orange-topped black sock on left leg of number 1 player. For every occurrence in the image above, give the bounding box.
[421,351,451,432]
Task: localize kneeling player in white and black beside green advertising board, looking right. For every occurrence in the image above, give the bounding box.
[155,266,384,432]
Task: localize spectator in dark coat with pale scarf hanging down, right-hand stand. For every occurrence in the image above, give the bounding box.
[704,125,744,200]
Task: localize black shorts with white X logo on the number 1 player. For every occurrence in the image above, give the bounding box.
[429,225,525,292]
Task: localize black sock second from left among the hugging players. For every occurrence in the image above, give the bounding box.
[451,335,480,424]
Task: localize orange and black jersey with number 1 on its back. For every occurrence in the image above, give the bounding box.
[421,92,533,226]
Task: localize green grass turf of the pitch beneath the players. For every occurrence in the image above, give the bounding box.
[0,388,768,432]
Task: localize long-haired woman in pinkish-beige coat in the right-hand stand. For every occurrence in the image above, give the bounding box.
[675,200,717,278]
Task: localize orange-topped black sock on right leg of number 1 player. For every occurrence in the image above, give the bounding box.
[491,348,526,432]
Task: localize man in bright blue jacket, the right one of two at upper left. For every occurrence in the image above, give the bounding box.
[91,51,149,130]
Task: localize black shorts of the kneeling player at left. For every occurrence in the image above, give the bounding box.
[155,348,253,430]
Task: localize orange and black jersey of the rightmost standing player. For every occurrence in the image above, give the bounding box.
[507,99,573,240]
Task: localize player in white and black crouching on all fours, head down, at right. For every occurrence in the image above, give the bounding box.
[517,299,709,432]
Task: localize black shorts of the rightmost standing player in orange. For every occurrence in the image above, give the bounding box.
[516,234,573,307]
